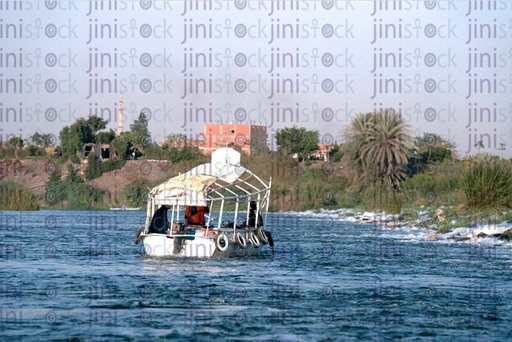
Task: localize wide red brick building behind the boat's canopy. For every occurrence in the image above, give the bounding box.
[199,124,268,155]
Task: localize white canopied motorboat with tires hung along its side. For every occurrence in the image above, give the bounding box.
[134,148,273,257]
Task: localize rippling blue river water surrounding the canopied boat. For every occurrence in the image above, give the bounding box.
[0,210,512,341]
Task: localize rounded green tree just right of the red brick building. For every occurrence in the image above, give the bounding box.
[276,126,320,158]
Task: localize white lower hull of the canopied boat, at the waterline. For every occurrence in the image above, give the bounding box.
[143,231,265,258]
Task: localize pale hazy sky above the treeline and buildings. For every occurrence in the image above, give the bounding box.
[0,1,512,157]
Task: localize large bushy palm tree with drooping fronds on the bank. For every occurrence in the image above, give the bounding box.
[345,109,413,187]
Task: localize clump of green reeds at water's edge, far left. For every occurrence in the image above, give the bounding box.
[0,182,39,210]
